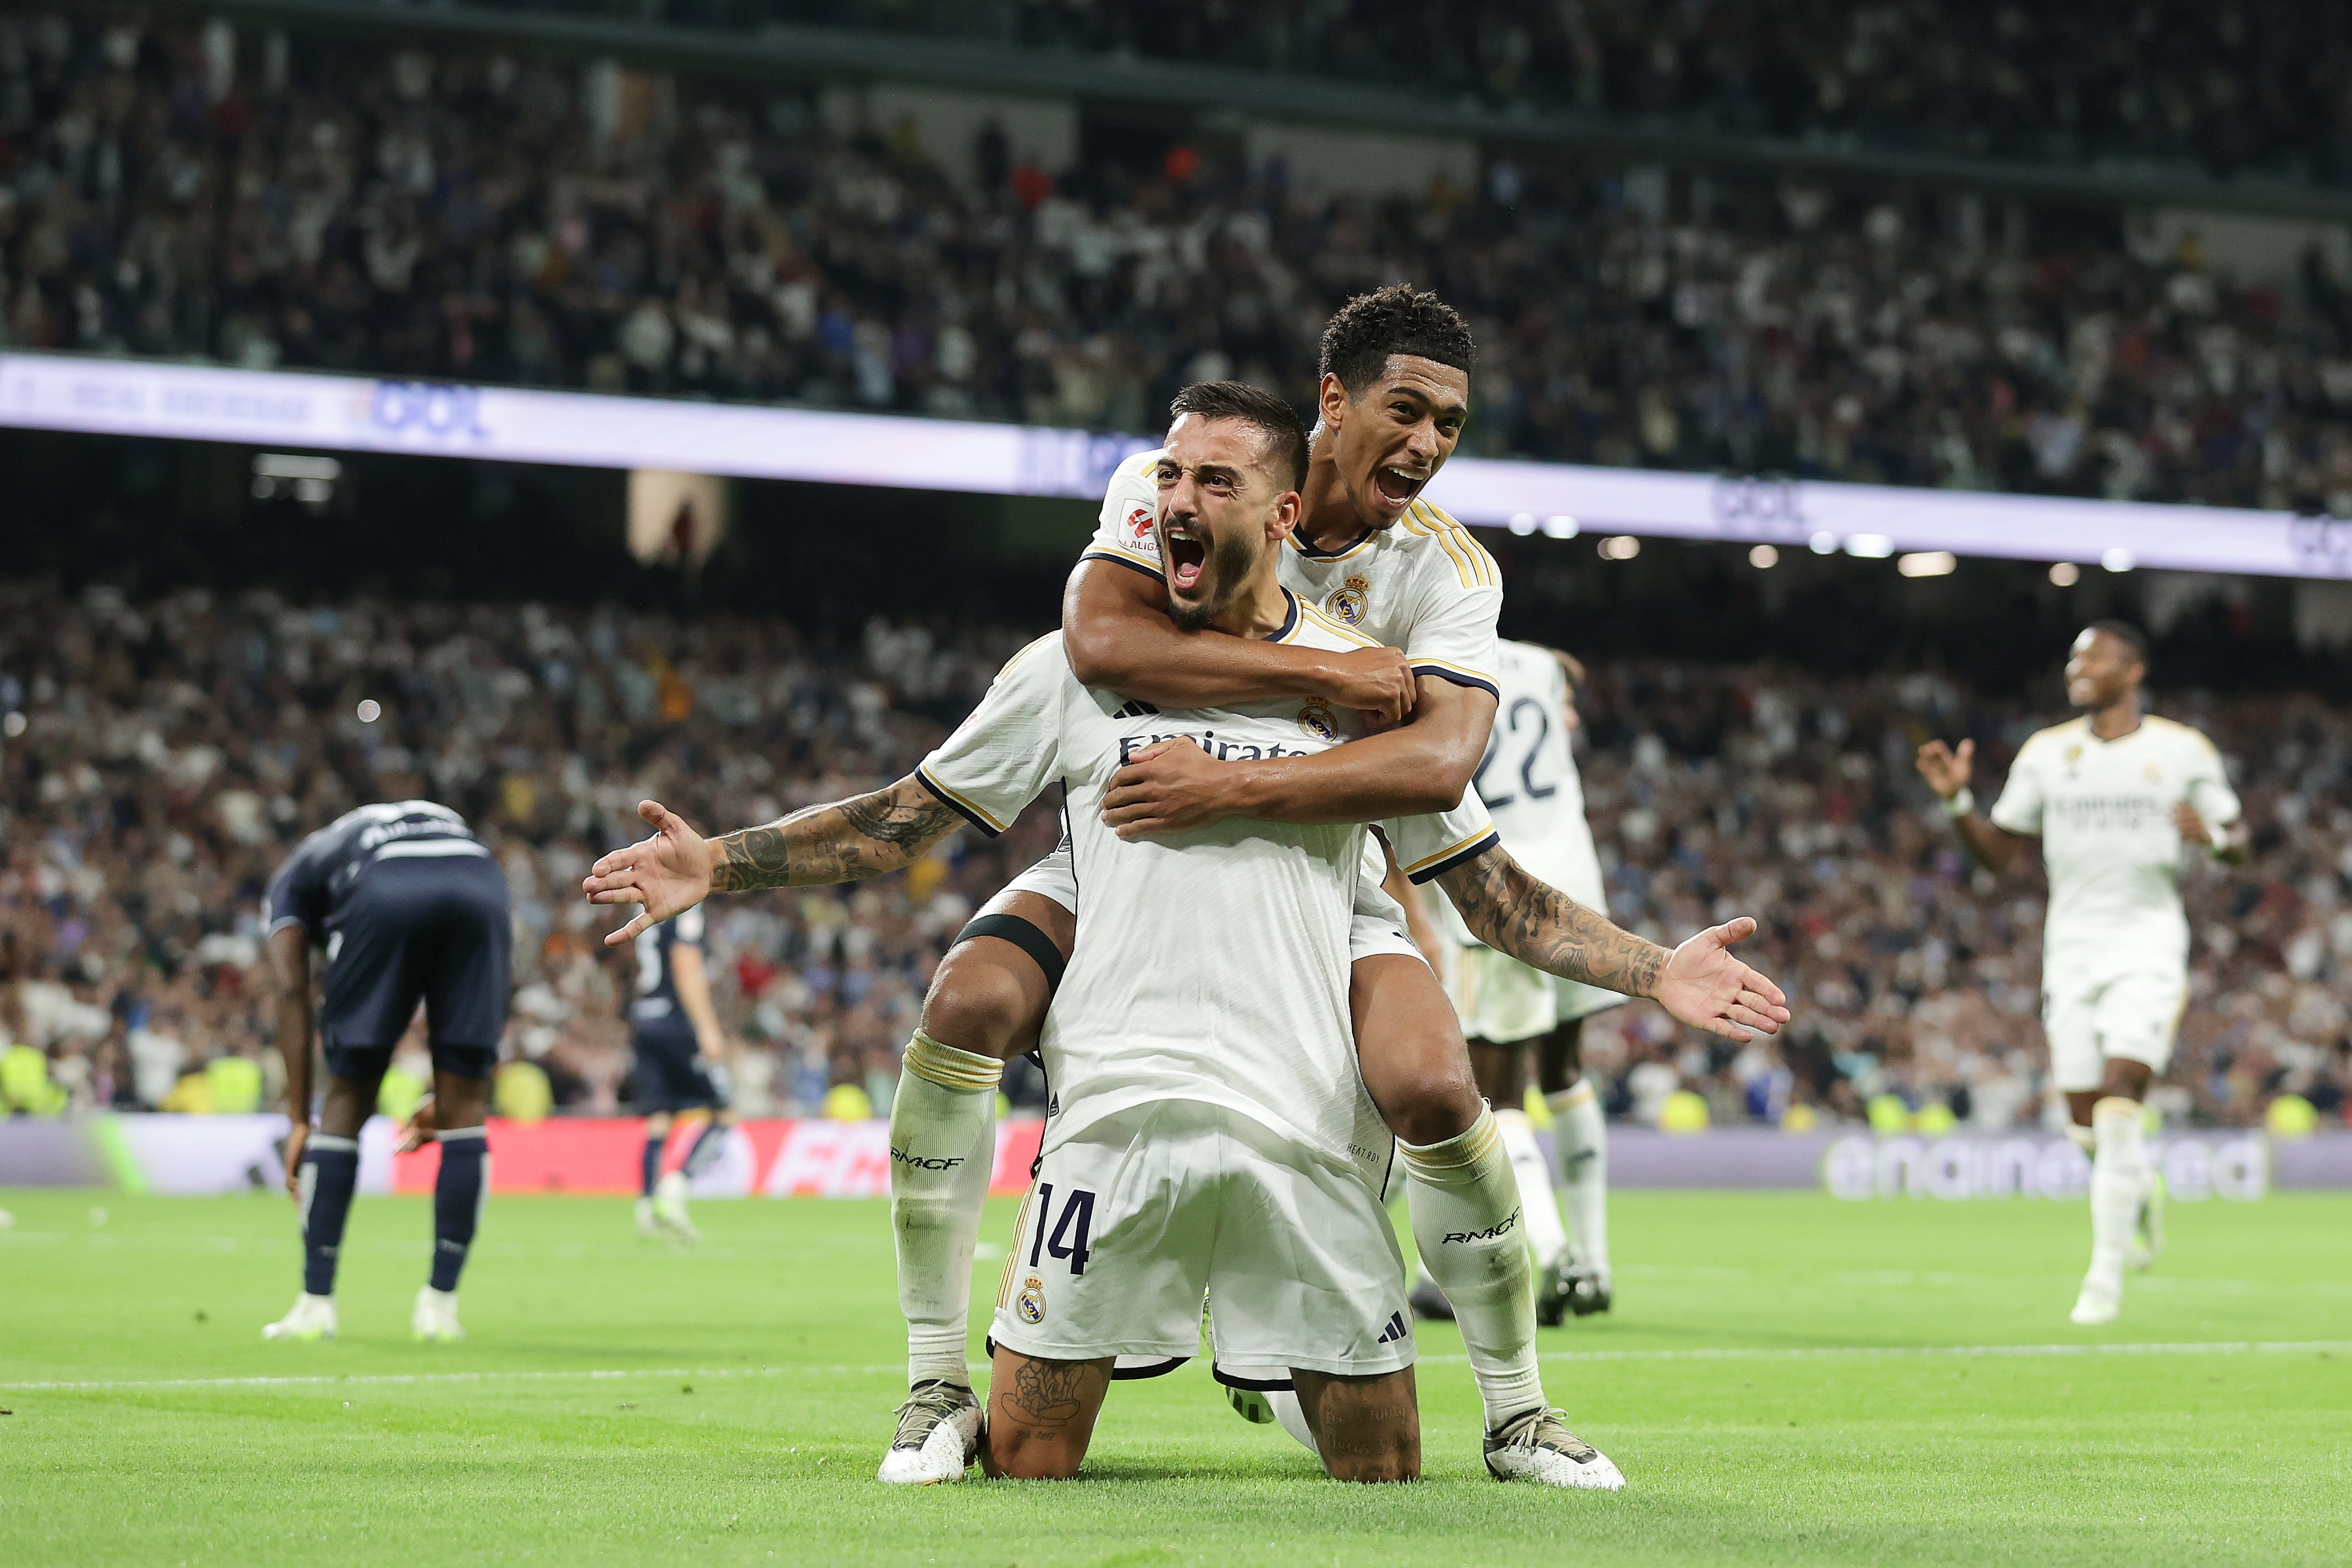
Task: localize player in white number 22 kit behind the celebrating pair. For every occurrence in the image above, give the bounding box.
[1407,642,1625,1326]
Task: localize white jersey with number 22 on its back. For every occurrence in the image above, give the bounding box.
[1430,642,1609,945]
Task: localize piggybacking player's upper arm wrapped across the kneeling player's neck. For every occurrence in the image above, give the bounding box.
[1061,555,1416,724]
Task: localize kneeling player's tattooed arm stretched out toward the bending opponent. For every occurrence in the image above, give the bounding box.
[581,776,965,947]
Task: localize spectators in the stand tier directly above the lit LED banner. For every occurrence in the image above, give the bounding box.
[14,18,2352,515]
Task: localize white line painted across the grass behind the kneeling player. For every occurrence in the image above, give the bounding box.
[18,1340,2352,1392]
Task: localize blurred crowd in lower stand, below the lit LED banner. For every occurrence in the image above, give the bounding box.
[0,581,2352,1126]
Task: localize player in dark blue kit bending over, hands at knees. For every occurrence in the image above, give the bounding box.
[261,799,513,1340]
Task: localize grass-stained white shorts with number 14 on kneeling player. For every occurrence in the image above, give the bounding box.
[990,1100,1413,1378]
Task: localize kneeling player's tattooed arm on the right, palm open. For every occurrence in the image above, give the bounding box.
[1437,844,1788,1041]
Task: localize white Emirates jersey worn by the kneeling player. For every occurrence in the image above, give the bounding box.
[917,611,1494,1183]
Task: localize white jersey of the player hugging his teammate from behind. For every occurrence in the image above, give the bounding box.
[1087,451,1503,691]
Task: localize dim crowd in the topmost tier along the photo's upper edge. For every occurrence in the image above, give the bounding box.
[472,0,2352,184]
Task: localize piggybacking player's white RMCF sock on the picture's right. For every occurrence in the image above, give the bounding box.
[1397,1109,1543,1432]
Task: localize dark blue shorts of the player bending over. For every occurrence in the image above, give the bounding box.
[320,855,513,1081]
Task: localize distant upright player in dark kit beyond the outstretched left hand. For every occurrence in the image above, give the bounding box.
[628,910,734,1241]
